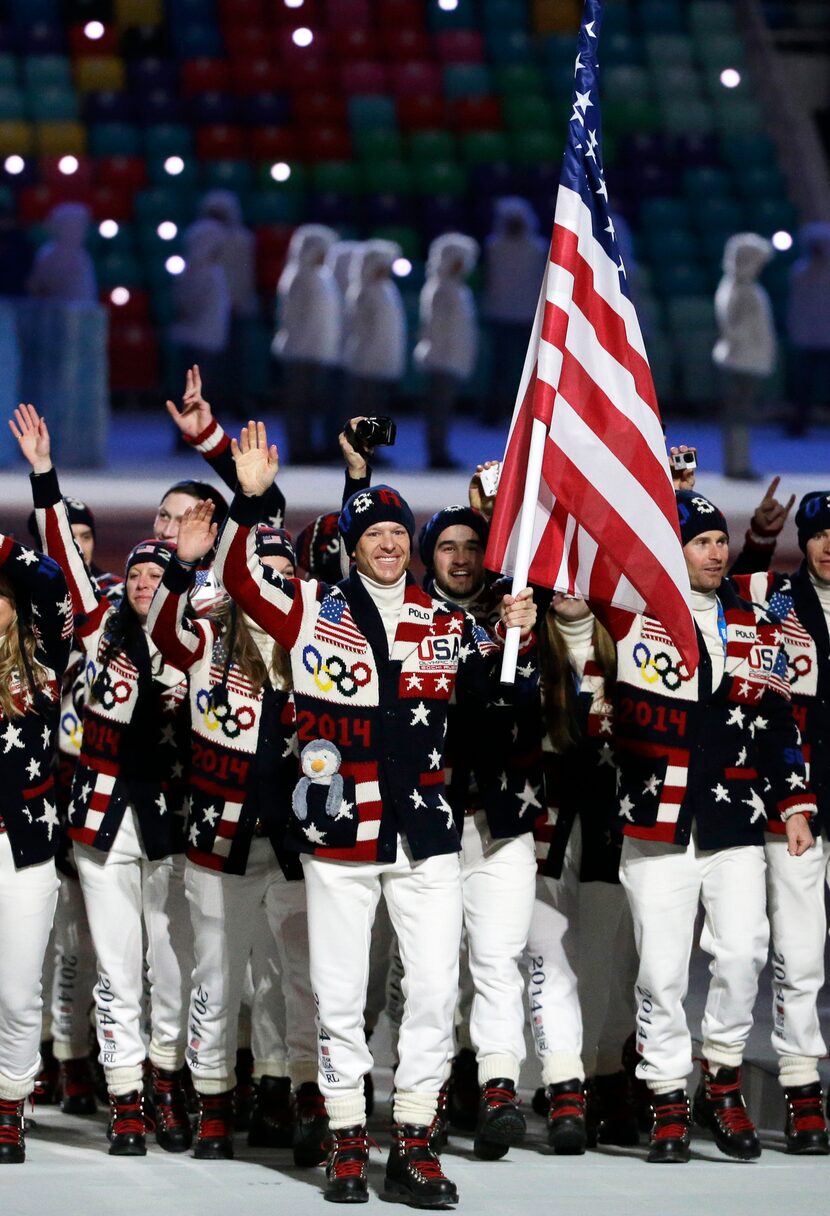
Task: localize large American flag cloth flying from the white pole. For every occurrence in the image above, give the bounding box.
[486,0,698,671]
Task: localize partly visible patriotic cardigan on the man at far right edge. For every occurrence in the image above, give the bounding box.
[735,562,830,835]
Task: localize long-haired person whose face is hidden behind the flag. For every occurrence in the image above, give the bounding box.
[527,593,638,1154]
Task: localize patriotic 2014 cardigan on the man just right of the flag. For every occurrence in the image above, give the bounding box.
[615,582,815,849]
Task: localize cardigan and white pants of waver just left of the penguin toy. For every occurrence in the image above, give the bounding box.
[148,549,321,1160]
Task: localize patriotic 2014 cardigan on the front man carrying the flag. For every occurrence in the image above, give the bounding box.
[216,495,524,861]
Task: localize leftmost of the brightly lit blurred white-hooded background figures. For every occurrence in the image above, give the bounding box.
[271,224,343,465]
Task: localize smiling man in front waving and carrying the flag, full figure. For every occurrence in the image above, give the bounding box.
[216,423,536,1207]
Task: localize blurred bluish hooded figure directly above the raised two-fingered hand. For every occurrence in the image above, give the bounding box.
[170,220,231,395]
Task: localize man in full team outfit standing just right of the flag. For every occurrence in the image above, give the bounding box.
[615,490,815,1162]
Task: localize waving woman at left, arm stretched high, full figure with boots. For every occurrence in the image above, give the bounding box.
[12,405,192,1156]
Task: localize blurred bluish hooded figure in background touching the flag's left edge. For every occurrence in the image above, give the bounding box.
[482,197,549,426]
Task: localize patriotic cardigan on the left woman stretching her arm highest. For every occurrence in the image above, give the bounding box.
[32,469,187,861]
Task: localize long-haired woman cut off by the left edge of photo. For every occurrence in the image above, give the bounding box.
[0,533,72,1164]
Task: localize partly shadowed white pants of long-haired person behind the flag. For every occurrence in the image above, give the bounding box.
[527,818,637,1086]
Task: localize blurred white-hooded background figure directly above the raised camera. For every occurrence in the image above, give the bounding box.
[344,240,406,417]
